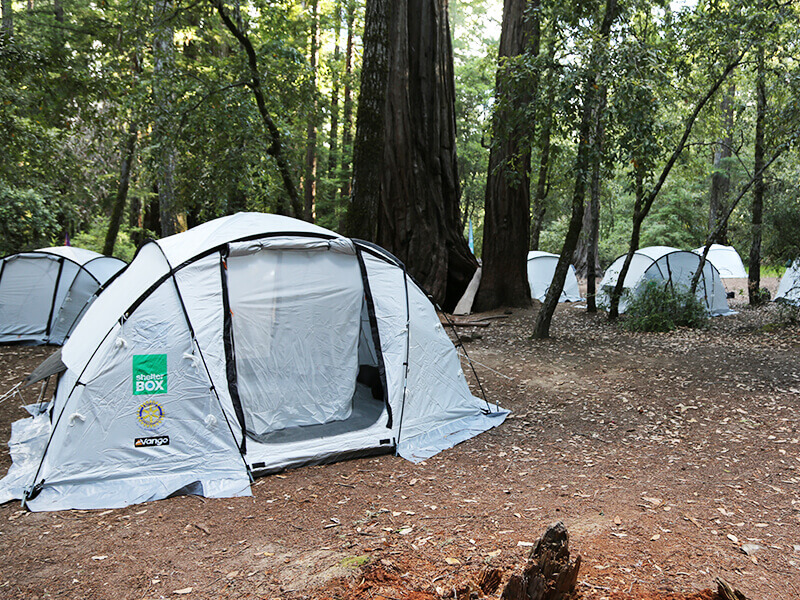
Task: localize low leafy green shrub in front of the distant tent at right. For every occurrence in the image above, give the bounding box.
[623,281,708,331]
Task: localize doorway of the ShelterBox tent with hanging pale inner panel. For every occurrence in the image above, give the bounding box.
[227,247,383,443]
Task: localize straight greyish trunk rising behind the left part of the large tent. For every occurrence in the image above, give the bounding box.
[153,0,179,236]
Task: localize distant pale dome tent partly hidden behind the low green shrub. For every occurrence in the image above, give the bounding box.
[597,246,734,316]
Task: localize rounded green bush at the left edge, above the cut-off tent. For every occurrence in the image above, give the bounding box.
[0,181,59,255]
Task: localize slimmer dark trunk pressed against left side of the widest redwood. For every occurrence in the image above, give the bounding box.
[345,0,393,241]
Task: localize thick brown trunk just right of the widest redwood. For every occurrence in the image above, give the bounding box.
[475,0,539,311]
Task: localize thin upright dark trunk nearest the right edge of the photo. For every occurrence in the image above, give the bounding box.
[747,45,767,306]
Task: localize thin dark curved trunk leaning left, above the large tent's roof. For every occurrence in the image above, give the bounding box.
[209,0,303,218]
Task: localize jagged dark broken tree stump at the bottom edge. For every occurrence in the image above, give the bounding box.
[500,521,581,600]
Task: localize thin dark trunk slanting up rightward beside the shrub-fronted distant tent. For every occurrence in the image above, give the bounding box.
[608,45,750,321]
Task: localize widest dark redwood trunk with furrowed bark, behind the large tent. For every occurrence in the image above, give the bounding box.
[374,0,478,310]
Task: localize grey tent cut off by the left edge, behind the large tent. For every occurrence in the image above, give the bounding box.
[0,246,125,345]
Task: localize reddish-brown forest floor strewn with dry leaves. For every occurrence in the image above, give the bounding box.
[0,283,800,600]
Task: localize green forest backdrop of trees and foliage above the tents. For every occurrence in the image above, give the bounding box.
[0,0,800,293]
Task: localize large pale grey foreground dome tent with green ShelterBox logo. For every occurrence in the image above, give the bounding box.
[0,213,508,511]
